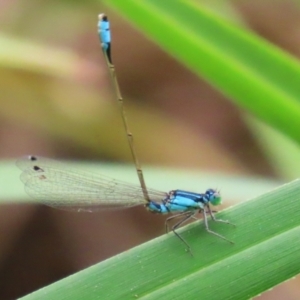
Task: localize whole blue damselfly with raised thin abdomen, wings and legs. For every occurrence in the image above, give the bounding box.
[17,14,233,253]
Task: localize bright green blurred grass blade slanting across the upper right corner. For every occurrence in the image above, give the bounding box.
[106,0,300,143]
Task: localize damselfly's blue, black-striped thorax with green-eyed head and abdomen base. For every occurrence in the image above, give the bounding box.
[146,189,221,214]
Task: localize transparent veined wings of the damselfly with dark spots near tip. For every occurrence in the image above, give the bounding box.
[16,156,166,212]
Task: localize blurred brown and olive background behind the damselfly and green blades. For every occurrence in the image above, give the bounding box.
[0,0,300,299]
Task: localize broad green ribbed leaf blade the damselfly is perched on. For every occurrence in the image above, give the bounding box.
[17,180,300,300]
